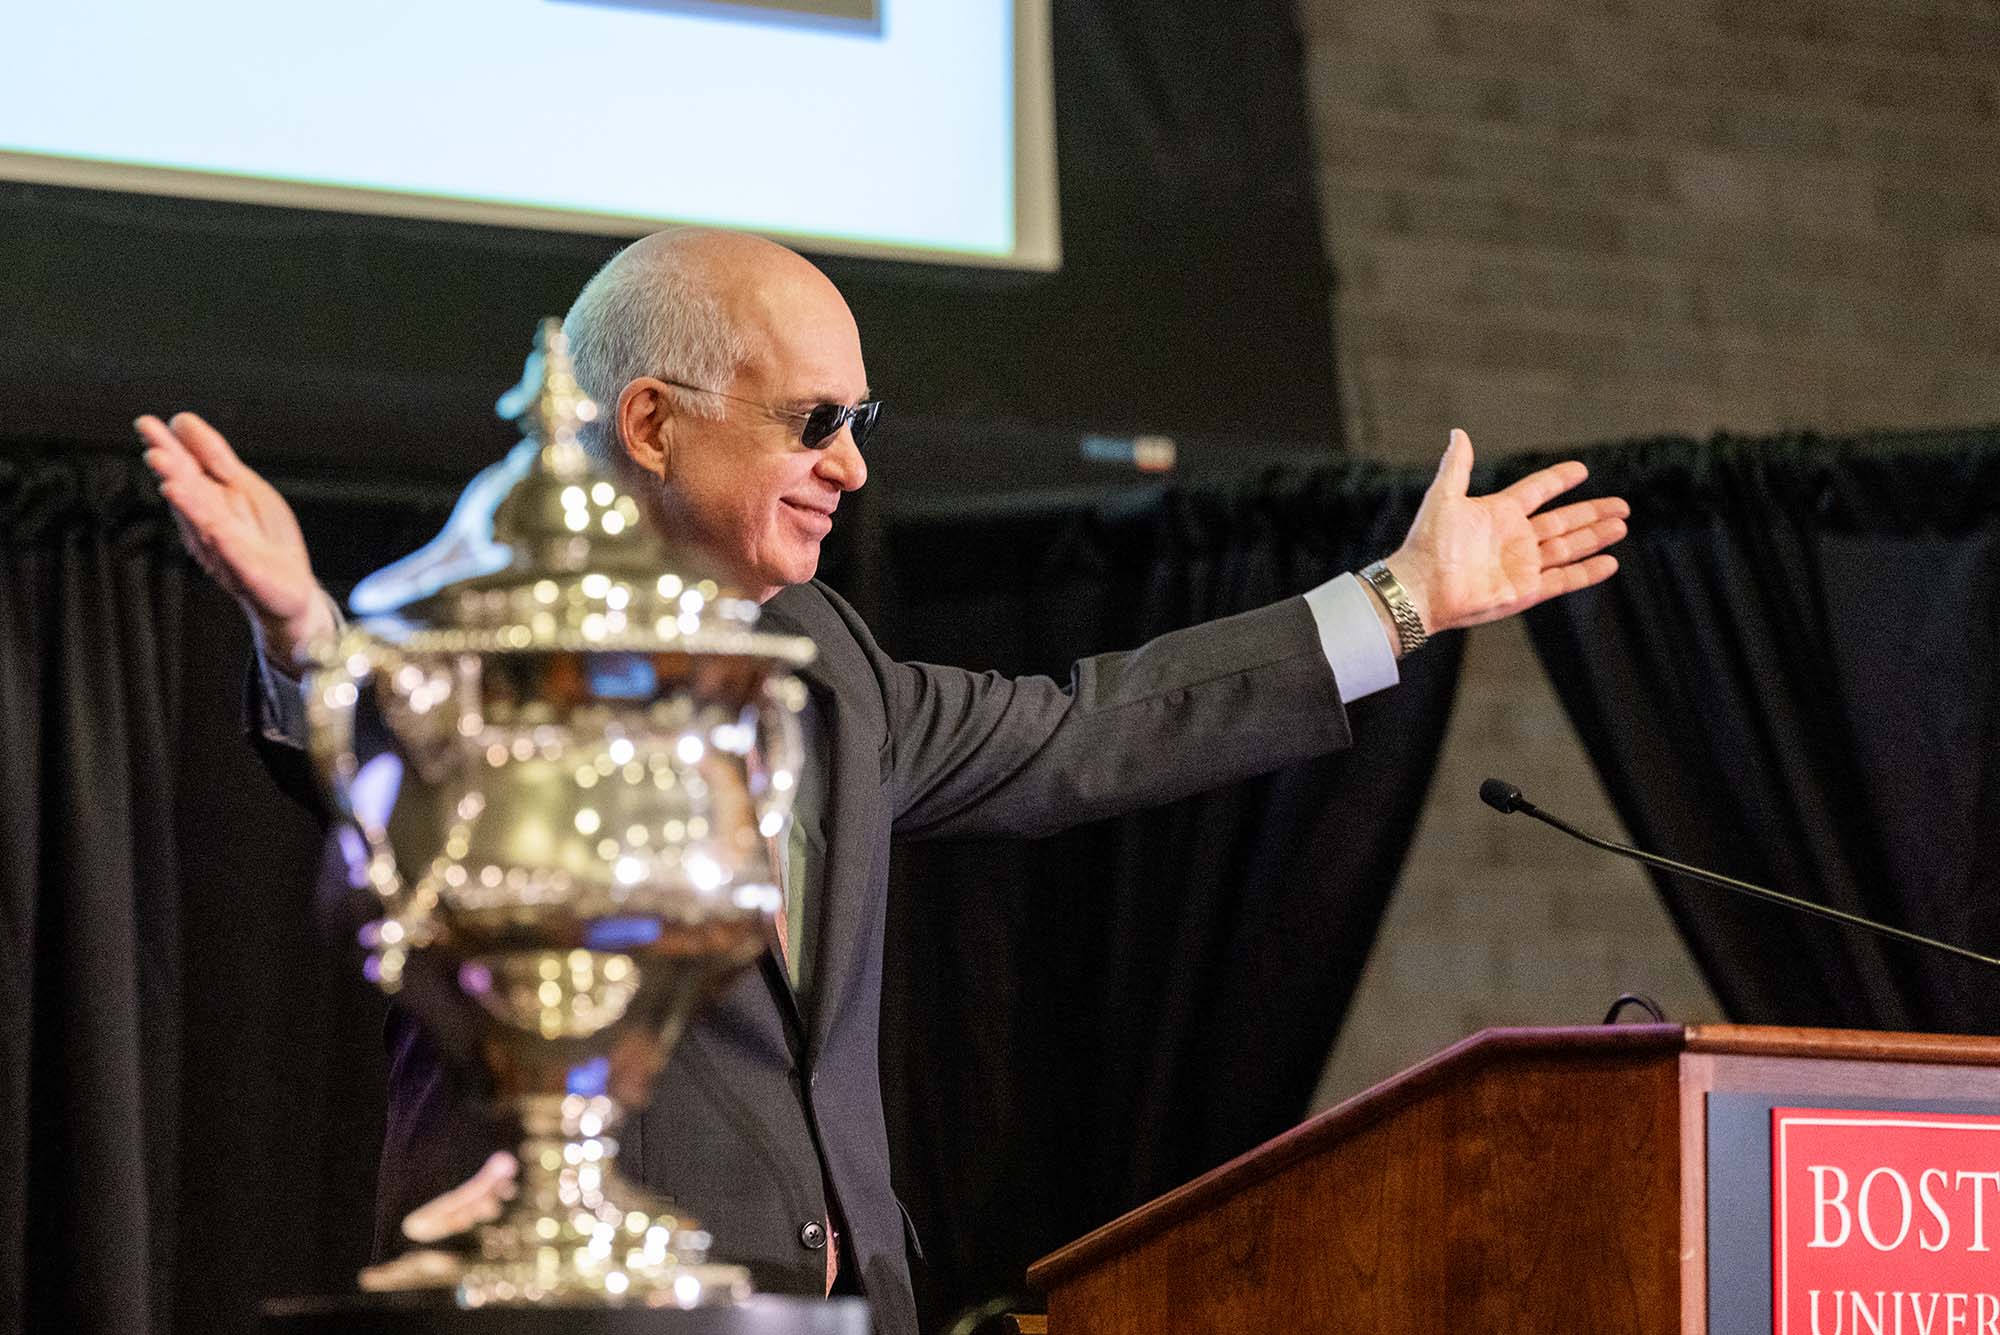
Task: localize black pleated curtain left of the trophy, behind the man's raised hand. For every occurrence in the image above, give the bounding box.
[0,450,442,1335]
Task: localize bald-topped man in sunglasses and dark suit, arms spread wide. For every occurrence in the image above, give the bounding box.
[138,230,1628,1335]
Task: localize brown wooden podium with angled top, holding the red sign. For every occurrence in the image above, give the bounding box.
[1028,1025,2000,1335]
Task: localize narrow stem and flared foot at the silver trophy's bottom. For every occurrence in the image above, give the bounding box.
[458,1093,750,1307]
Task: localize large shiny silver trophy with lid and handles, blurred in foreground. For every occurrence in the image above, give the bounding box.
[306,320,812,1307]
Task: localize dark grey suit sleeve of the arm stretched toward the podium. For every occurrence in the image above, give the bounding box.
[878,598,1348,837]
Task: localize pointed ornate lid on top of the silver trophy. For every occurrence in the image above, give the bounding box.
[348,318,814,668]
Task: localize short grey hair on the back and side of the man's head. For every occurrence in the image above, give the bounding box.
[562,236,750,466]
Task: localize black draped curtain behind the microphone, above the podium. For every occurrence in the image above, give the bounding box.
[1510,430,2000,1033]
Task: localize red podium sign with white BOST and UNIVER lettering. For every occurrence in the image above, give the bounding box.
[1770,1107,2000,1335]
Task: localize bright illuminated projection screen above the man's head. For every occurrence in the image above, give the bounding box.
[0,0,1058,268]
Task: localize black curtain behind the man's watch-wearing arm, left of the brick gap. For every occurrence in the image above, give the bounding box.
[878,464,1460,1319]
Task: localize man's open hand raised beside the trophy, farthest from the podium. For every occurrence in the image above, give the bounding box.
[132,412,334,673]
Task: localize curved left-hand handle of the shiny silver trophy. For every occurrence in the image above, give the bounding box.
[306,630,430,991]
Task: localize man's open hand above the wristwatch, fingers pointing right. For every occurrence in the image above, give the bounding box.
[1388,430,1632,644]
